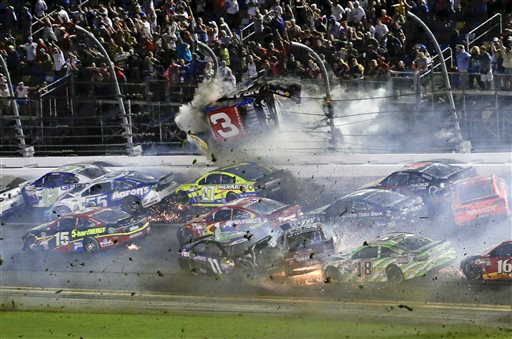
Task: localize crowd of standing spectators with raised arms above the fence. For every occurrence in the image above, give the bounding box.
[0,0,512,105]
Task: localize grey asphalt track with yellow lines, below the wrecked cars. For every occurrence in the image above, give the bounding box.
[0,166,512,327]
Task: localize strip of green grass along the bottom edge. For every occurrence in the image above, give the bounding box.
[0,311,512,339]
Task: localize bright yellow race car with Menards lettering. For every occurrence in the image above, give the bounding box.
[176,163,290,206]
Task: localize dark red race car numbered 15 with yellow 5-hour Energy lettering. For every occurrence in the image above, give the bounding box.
[22,208,150,252]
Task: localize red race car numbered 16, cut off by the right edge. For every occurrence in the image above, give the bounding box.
[460,240,512,281]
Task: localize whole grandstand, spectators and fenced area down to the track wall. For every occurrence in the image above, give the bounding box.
[0,0,512,156]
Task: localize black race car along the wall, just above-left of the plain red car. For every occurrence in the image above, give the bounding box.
[370,161,477,199]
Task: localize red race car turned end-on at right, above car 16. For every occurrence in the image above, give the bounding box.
[453,175,510,226]
